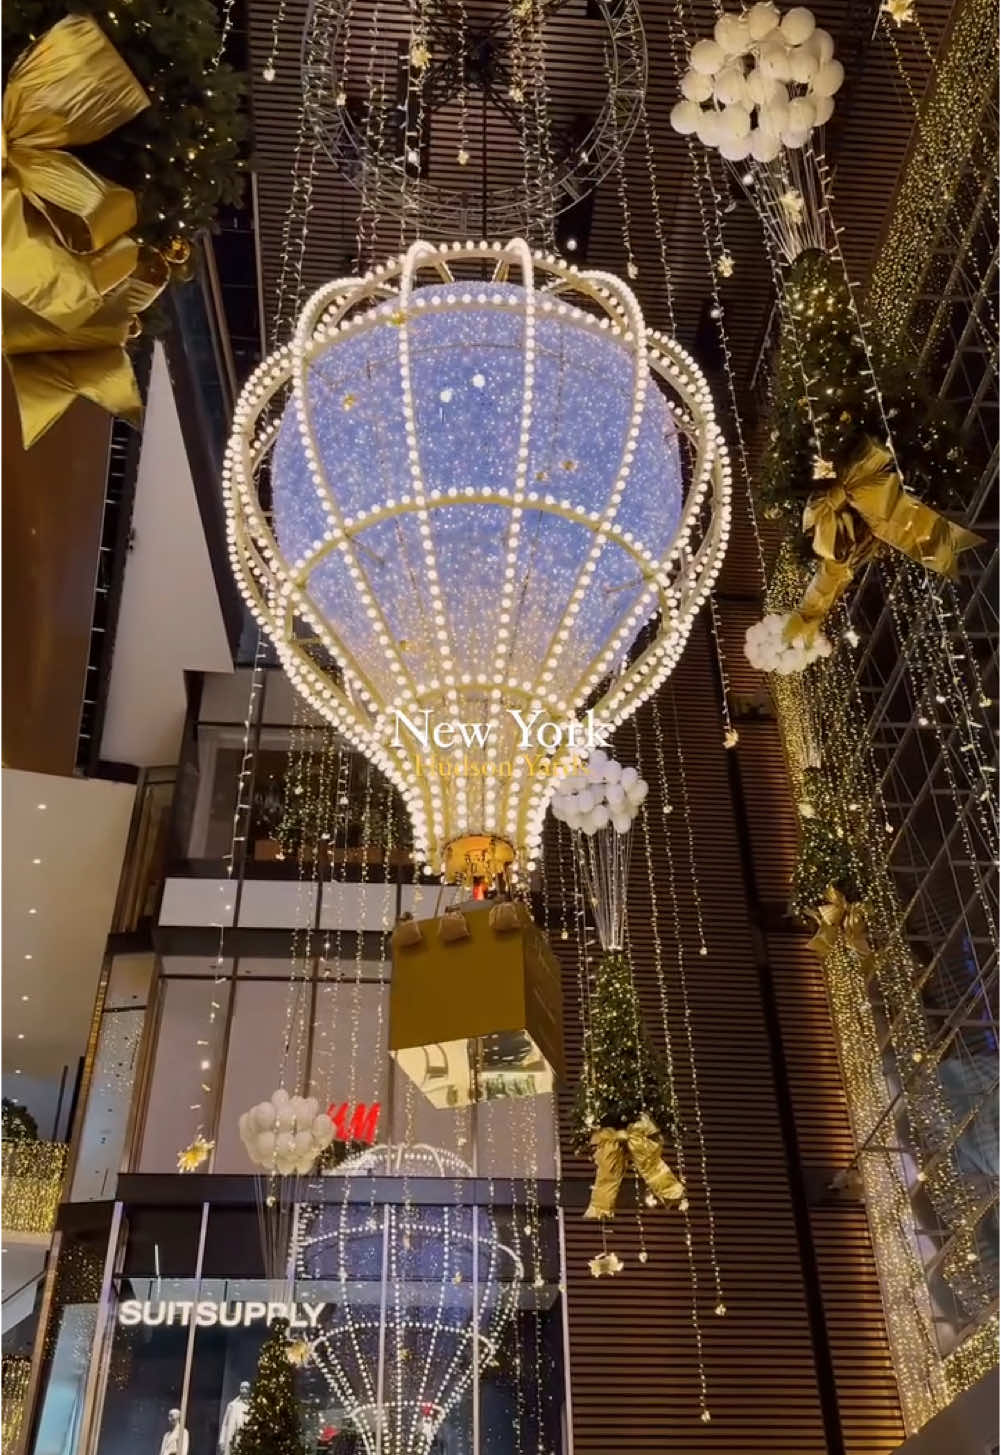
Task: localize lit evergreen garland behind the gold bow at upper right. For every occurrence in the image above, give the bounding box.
[758,250,966,538]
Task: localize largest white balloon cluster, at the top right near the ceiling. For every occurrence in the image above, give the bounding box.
[671,0,844,162]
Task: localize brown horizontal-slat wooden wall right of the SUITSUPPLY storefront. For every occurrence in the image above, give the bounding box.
[549,630,828,1455]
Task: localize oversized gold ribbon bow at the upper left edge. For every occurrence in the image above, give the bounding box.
[3,15,169,448]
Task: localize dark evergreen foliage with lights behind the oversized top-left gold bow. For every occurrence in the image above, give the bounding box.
[3,0,247,249]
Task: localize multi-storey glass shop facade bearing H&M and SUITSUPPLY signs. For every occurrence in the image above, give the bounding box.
[29,672,565,1455]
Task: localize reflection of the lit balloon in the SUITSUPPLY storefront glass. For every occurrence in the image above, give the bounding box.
[297,1145,524,1455]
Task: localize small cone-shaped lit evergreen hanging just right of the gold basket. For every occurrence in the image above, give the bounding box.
[573,950,674,1151]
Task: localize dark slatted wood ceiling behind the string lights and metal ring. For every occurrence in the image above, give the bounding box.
[249,0,950,386]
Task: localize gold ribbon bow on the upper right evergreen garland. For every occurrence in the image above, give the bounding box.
[799,439,984,623]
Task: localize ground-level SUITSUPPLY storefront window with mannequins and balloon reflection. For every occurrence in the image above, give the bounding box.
[69,1193,565,1455]
